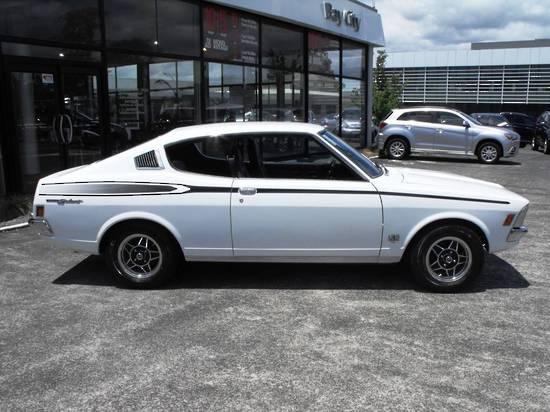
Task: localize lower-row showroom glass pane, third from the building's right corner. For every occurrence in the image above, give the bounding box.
[261,69,305,122]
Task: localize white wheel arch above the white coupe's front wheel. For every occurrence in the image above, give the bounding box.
[402,214,490,259]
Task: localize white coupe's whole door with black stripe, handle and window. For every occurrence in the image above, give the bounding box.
[231,134,382,262]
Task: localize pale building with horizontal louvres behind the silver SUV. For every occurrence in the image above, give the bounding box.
[386,39,550,116]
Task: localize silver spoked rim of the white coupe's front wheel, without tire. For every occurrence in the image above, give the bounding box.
[426,236,472,283]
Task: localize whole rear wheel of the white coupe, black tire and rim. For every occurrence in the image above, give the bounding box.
[105,222,181,288]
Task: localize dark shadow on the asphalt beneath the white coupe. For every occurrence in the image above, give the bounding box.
[53,255,529,293]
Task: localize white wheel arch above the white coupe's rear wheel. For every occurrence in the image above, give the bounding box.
[97,212,185,257]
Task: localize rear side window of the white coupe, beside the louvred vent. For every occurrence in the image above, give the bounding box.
[165,137,234,177]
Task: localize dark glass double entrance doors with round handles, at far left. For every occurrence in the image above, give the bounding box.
[7,63,103,193]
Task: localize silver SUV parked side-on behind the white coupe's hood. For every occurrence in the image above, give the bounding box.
[377,107,520,163]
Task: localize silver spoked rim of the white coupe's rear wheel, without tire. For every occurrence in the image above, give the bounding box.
[117,233,163,280]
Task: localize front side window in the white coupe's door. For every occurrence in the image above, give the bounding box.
[238,134,363,180]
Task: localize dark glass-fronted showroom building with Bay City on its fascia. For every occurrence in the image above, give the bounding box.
[0,0,384,194]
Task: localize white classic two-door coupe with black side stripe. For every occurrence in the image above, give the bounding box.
[30,122,529,291]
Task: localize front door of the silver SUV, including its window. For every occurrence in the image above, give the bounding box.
[434,112,470,153]
